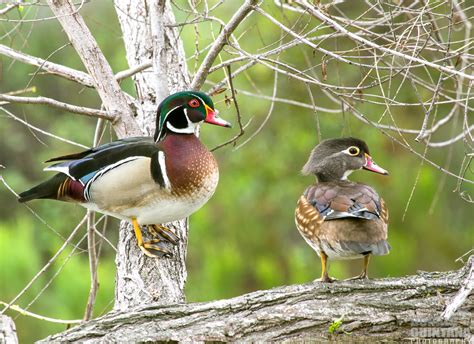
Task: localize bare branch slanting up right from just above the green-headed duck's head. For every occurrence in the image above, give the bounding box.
[191,0,260,90]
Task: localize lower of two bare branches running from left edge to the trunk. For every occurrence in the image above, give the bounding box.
[0,94,115,121]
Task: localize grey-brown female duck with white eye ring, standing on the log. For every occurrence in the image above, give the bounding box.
[295,137,390,282]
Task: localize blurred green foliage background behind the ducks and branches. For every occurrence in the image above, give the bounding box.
[0,1,474,342]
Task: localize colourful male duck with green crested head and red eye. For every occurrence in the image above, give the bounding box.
[19,91,230,257]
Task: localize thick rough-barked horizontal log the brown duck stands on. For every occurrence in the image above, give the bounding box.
[44,257,474,343]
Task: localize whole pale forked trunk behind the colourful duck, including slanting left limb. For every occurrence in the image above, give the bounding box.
[44,0,189,310]
